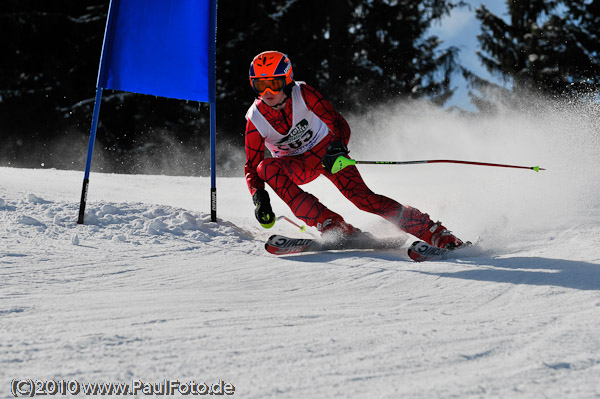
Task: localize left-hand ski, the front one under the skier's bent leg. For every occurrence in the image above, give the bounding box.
[265,234,404,255]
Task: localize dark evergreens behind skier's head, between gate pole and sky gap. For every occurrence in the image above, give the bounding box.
[217,0,464,120]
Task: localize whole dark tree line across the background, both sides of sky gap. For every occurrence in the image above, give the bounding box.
[0,0,600,174]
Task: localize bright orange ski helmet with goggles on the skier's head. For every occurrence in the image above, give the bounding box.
[250,51,294,94]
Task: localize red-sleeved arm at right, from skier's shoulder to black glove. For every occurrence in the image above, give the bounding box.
[300,84,350,145]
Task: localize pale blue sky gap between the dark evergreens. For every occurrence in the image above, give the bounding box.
[431,0,506,111]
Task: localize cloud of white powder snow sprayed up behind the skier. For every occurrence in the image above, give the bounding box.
[347,94,600,250]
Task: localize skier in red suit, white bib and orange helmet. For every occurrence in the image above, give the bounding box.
[244,51,463,249]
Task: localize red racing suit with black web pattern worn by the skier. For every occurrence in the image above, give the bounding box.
[244,83,433,237]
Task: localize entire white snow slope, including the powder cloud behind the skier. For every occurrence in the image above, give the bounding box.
[0,101,600,398]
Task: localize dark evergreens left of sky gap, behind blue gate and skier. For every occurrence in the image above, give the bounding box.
[0,0,463,174]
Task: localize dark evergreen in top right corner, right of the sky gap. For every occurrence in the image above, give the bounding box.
[472,0,600,107]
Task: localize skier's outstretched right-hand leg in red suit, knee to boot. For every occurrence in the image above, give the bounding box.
[323,166,462,247]
